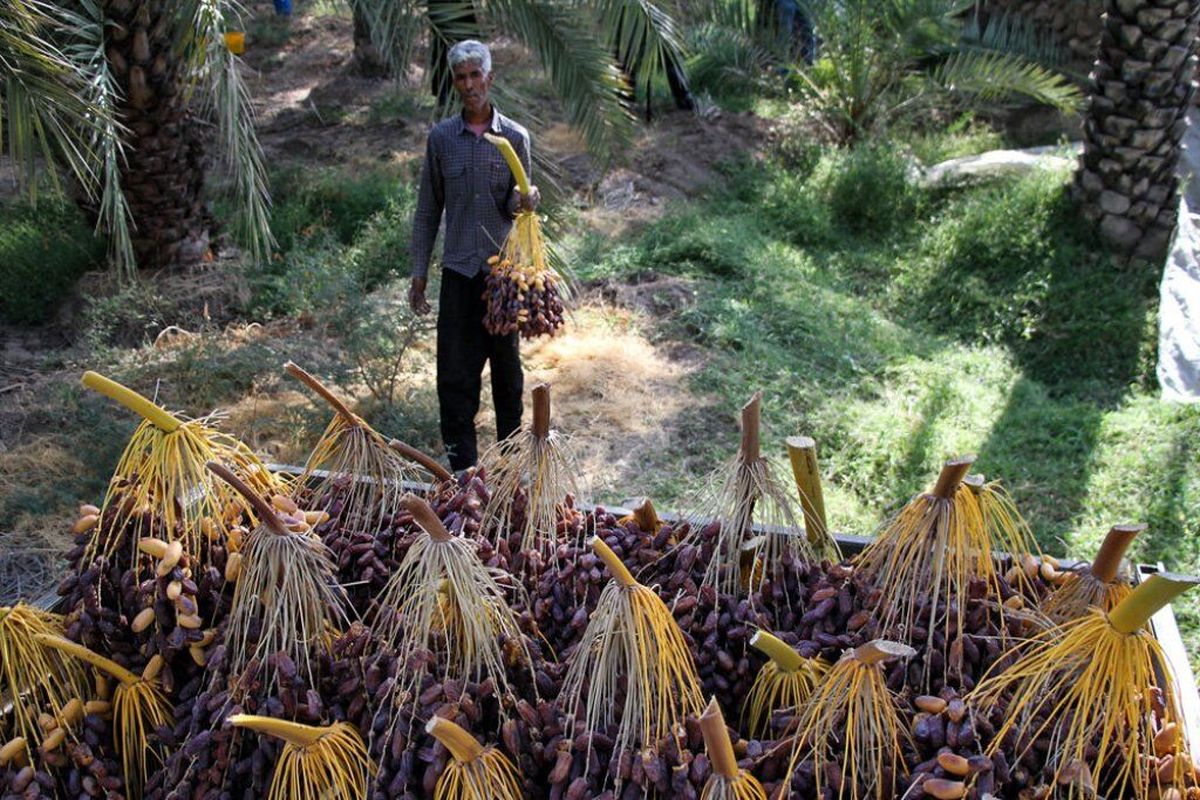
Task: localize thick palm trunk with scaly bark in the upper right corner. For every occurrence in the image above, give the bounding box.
[1075,0,1200,259]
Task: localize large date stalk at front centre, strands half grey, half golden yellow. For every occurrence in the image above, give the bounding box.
[560,537,703,782]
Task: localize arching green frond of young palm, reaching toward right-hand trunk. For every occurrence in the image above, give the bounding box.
[932,50,1084,113]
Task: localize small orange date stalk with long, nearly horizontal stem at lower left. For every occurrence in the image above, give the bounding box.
[34,633,173,796]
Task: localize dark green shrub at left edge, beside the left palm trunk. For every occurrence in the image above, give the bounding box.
[0,201,104,325]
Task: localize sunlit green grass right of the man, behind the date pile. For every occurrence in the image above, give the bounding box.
[576,150,1200,654]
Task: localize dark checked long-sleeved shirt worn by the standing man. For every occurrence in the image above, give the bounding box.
[412,106,529,278]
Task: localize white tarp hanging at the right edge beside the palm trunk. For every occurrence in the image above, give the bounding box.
[1158,200,1200,403]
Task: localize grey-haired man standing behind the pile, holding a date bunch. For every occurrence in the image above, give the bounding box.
[408,40,539,471]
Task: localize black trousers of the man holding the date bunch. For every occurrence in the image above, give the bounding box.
[438,270,524,471]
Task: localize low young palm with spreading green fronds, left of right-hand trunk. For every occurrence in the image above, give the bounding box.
[797,0,1081,144]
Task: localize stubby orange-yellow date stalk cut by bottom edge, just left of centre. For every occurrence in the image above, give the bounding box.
[425,716,524,800]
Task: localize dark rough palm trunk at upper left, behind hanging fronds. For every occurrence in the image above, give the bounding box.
[104,0,210,269]
